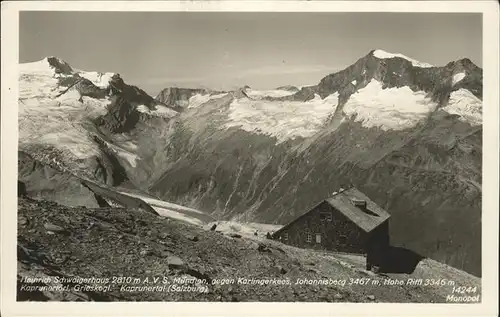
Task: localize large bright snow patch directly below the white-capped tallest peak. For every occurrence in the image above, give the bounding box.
[343,79,437,131]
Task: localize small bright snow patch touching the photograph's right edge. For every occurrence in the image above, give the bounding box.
[442,88,483,125]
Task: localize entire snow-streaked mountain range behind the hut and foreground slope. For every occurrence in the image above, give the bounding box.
[18,50,482,276]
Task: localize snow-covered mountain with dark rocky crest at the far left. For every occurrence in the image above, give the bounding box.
[18,56,177,182]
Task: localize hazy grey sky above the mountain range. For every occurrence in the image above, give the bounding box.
[19,11,482,96]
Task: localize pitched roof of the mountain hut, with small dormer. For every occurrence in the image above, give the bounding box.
[274,187,390,235]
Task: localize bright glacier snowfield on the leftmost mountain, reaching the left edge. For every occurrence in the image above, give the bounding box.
[18,60,110,161]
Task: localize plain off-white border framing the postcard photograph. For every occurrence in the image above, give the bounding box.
[0,1,500,316]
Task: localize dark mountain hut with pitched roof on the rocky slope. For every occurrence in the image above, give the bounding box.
[272,187,390,269]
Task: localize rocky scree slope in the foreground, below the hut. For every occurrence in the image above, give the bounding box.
[18,198,480,303]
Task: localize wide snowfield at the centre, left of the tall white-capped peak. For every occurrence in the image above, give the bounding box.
[226,92,339,143]
